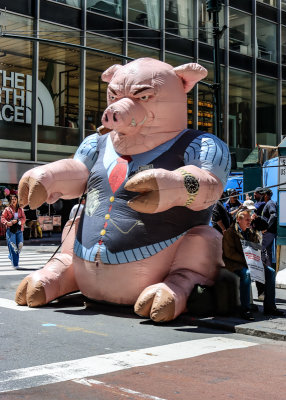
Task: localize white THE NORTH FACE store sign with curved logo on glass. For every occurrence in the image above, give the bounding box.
[0,70,55,126]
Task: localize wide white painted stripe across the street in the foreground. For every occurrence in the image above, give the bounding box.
[0,337,258,393]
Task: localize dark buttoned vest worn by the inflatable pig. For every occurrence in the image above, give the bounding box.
[76,130,212,258]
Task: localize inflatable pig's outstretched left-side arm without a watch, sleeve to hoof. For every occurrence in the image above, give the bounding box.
[19,134,99,209]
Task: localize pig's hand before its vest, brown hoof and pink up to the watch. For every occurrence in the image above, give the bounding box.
[125,168,187,214]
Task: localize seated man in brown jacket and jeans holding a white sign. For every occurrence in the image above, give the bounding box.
[223,206,284,321]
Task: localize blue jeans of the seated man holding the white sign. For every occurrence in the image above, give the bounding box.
[234,266,276,311]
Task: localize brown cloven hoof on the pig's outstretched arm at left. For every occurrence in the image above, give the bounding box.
[19,167,49,209]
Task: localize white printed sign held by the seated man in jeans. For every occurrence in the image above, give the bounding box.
[241,240,265,283]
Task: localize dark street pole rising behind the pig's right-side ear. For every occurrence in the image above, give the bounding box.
[206,0,226,138]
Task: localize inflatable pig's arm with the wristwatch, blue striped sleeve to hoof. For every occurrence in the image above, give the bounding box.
[125,134,230,213]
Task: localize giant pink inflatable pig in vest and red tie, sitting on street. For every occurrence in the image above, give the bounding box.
[16,58,230,322]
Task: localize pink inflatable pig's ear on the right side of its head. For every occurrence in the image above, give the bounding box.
[174,63,208,93]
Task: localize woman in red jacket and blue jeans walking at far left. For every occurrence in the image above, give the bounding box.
[1,194,26,268]
